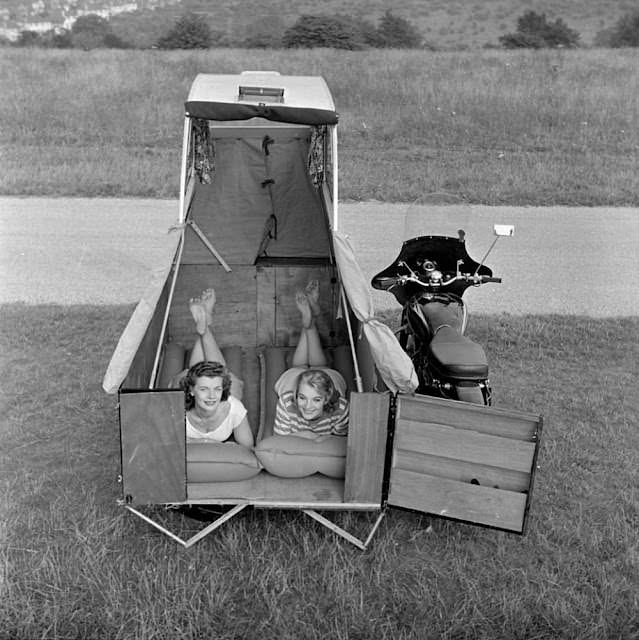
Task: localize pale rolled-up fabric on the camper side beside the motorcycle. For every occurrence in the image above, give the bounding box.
[333,231,418,393]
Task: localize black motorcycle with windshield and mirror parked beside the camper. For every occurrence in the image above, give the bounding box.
[371,225,514,405]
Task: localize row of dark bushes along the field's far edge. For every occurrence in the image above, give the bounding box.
[7,9,639,50]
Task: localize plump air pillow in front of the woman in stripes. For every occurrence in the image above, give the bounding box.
[255,435,347,478]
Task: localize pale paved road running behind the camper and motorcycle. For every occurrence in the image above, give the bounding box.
[0,197,639,317]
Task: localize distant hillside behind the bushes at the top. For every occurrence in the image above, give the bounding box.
[0,0,637,49]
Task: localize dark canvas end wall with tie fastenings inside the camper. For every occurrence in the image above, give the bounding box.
[180,132,330,266]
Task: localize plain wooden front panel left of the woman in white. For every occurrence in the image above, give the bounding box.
[120,390,186,504]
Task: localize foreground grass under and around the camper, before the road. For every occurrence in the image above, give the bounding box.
[0,305,639,640]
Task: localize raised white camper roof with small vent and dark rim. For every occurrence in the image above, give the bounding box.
[185,71,338,125]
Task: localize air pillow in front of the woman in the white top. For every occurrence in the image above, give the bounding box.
[186,442,262,482]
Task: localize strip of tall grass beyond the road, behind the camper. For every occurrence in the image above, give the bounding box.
[0,48,639,206]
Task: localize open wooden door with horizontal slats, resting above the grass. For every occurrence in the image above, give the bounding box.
[388,396,542,533]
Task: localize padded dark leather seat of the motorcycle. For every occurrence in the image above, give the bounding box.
[428,325,488,380]
